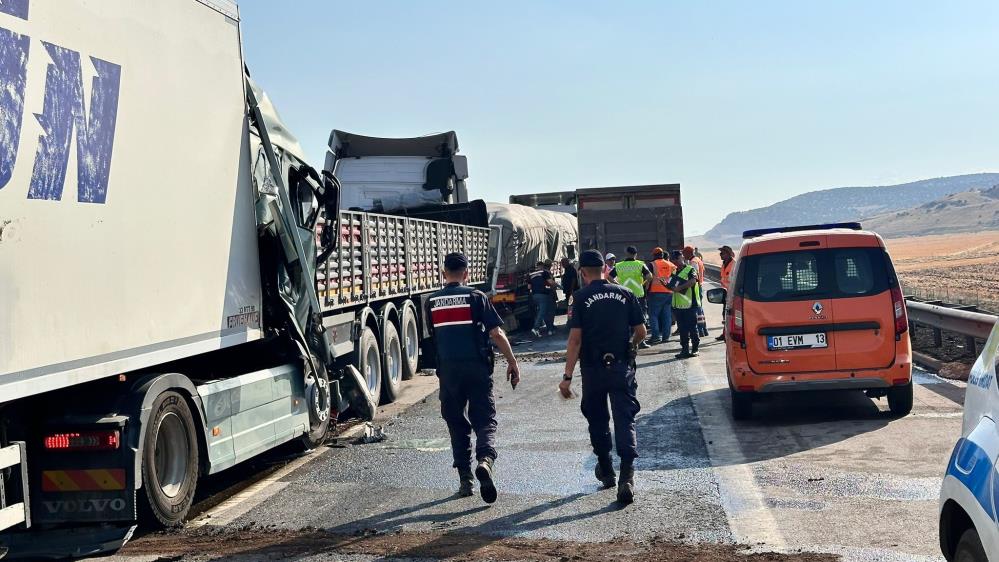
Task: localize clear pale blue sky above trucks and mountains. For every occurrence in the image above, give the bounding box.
[240,0,999,235]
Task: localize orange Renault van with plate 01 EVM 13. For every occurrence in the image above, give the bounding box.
[708,223,912,419]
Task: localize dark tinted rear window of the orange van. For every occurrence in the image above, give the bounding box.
[739,248,894,302]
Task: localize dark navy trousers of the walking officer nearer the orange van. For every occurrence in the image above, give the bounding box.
[580,362,641,462]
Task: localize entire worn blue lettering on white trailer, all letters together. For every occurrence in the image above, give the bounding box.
[0,0,121,203]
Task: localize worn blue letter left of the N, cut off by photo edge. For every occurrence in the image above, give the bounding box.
[0,26,31,189]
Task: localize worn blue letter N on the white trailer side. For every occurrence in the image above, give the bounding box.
[28,41,121,203]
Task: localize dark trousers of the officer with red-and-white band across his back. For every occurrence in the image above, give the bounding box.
[437,363,496,470]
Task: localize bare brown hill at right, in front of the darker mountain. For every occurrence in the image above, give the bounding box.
[863,185,999,238]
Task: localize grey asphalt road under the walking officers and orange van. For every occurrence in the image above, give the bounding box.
[103,296,964,561]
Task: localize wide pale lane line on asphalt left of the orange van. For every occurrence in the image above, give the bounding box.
[687,360,787,549]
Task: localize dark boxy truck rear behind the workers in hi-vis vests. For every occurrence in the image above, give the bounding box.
[576,184,683,255]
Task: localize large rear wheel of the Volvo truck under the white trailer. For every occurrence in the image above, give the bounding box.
[140,391,198,527]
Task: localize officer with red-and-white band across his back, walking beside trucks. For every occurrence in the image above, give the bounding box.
[425,253,520,503]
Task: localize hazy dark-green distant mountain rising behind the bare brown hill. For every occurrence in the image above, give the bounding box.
[704,174,999,244]
